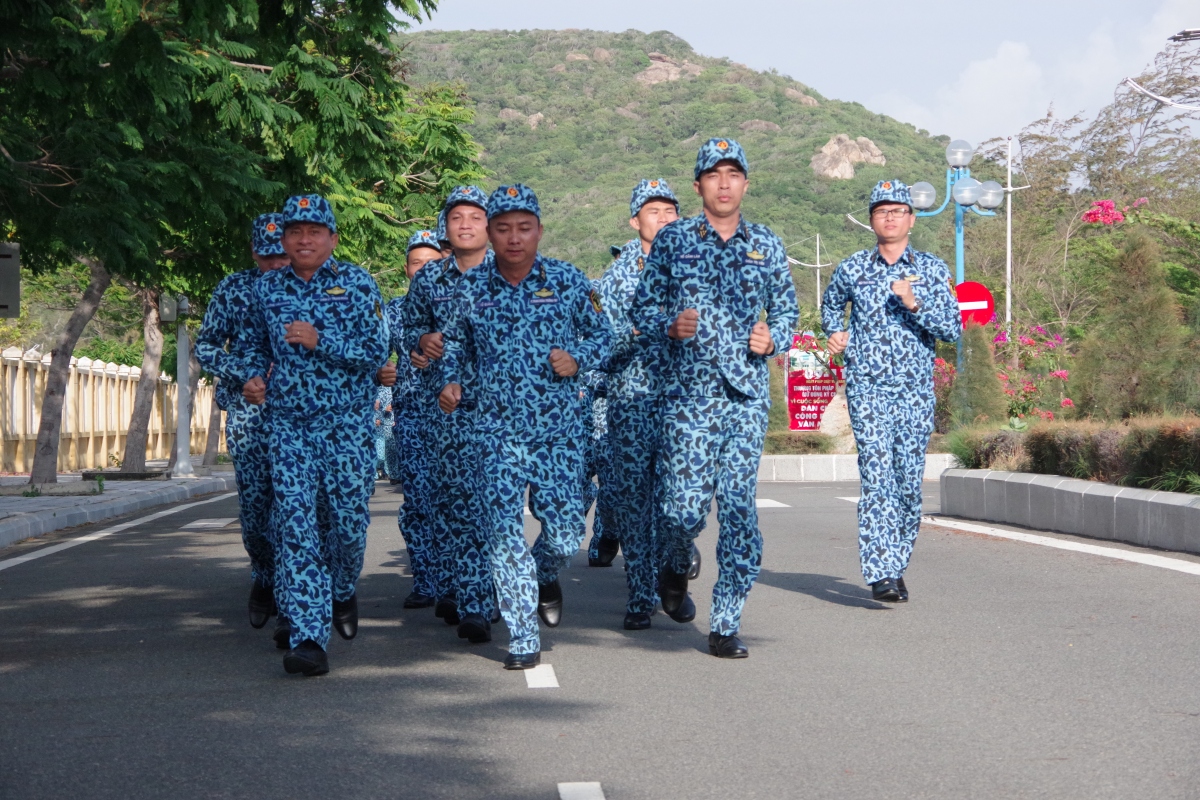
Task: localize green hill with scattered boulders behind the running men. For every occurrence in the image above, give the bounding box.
[401,30,993,303]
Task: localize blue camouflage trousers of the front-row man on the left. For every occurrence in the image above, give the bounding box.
[270,411,374,648]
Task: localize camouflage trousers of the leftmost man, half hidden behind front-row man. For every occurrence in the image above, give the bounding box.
[226,404,276,587]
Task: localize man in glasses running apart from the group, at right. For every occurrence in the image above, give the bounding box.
[821,181,961,602]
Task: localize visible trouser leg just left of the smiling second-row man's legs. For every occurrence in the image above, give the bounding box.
[392,395,440,597]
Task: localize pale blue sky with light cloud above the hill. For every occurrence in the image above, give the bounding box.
[413,0,1200,144]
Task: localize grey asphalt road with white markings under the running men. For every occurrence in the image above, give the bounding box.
[0,483,1200,800]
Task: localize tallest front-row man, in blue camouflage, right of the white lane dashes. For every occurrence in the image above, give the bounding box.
[632,139,799,658]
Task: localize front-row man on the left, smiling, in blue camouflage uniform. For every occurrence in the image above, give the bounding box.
[240,194,388,675]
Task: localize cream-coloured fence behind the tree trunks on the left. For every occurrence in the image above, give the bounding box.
[0,347,224,473]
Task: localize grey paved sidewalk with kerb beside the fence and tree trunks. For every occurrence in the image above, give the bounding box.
[0,456,238,547]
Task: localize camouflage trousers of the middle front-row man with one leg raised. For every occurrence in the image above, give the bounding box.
[481,434,584,654]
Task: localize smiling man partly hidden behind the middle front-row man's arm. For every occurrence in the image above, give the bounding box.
[403,186,494,643]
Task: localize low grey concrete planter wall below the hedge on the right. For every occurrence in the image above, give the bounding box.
[941,469,1200,553]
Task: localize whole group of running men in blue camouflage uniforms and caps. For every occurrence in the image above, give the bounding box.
[196,138,959,675]
